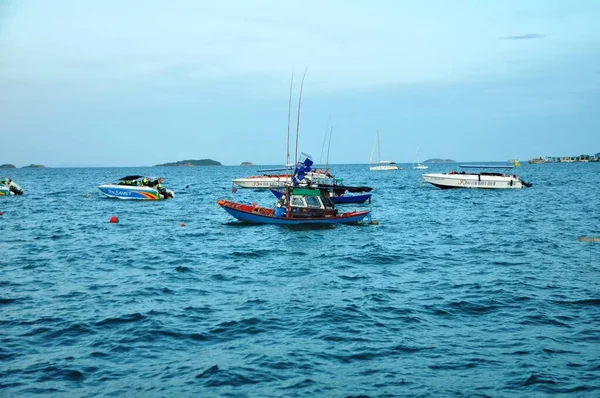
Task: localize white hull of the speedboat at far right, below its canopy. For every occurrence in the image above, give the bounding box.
[423,173,523,189]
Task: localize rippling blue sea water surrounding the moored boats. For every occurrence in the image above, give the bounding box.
[0,163,600,397]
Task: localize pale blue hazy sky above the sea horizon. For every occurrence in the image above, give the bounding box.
[0,0,600,167]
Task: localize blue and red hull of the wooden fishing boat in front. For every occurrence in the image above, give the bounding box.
[217,200,370,225]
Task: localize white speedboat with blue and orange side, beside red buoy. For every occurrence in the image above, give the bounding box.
[98,175,175,200]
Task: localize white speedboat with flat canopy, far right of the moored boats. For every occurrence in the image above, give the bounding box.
[422,165,532,189]
